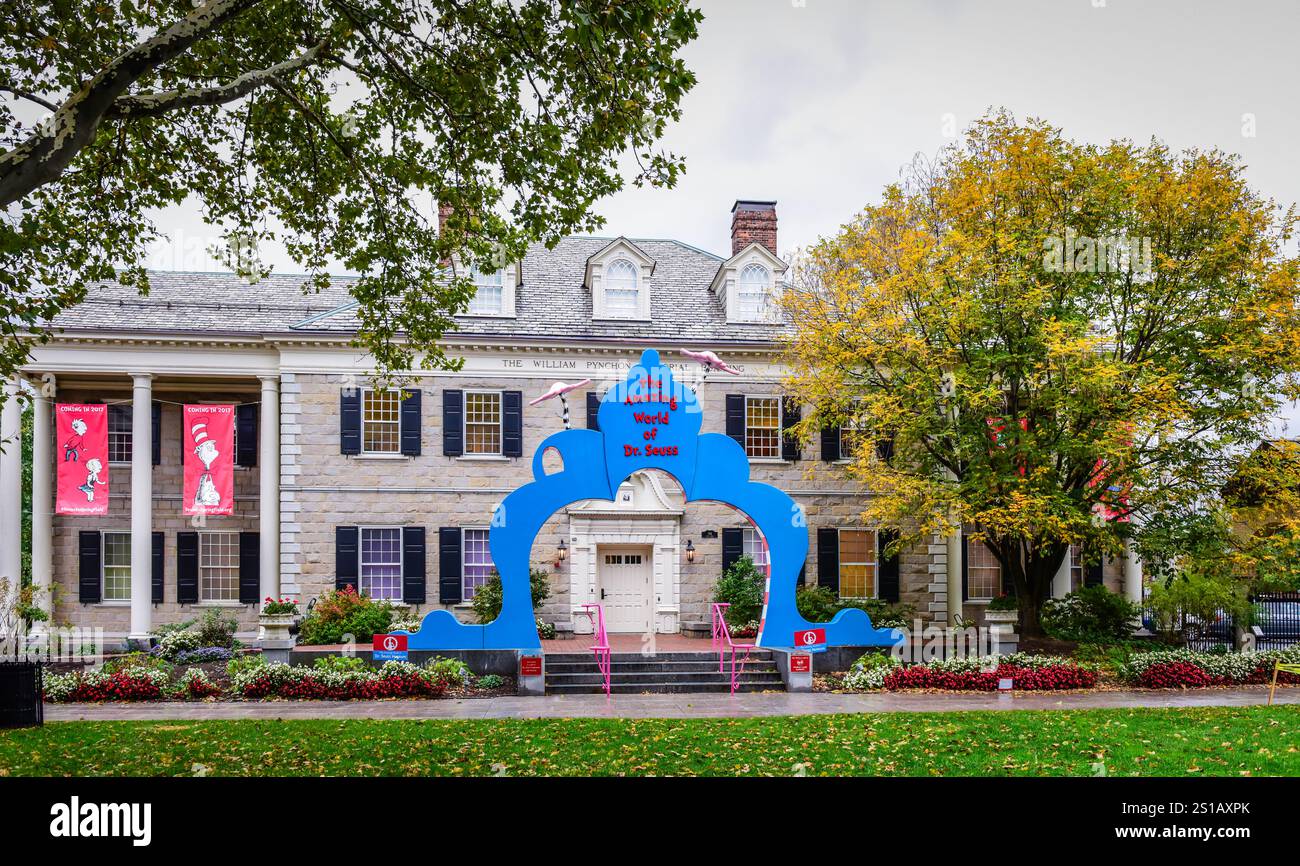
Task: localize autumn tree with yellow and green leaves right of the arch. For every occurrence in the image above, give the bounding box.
[785,113,1300,636]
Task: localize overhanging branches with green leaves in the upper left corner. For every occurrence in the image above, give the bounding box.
[0,0,702,378]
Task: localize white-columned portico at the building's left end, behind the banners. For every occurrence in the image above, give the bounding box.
[12,341,281,642]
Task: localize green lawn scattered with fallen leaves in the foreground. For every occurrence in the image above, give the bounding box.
[0,706,1300,776]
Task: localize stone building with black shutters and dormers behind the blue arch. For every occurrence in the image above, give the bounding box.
[0,202,1123,641]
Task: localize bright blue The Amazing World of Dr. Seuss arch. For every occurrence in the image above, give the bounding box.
[408,350,894,650]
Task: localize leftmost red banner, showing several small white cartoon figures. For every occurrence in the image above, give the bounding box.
[55,403,108,515]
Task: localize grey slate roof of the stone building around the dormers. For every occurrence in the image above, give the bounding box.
[51,237,787,343]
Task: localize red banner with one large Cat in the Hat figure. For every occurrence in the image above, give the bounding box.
[181,404,235,515]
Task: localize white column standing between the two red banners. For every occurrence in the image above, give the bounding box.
[127,373,153,641]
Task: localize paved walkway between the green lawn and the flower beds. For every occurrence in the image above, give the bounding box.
[46,685,1300,722]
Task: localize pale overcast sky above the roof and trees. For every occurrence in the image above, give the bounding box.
[142,0,1300,436]
